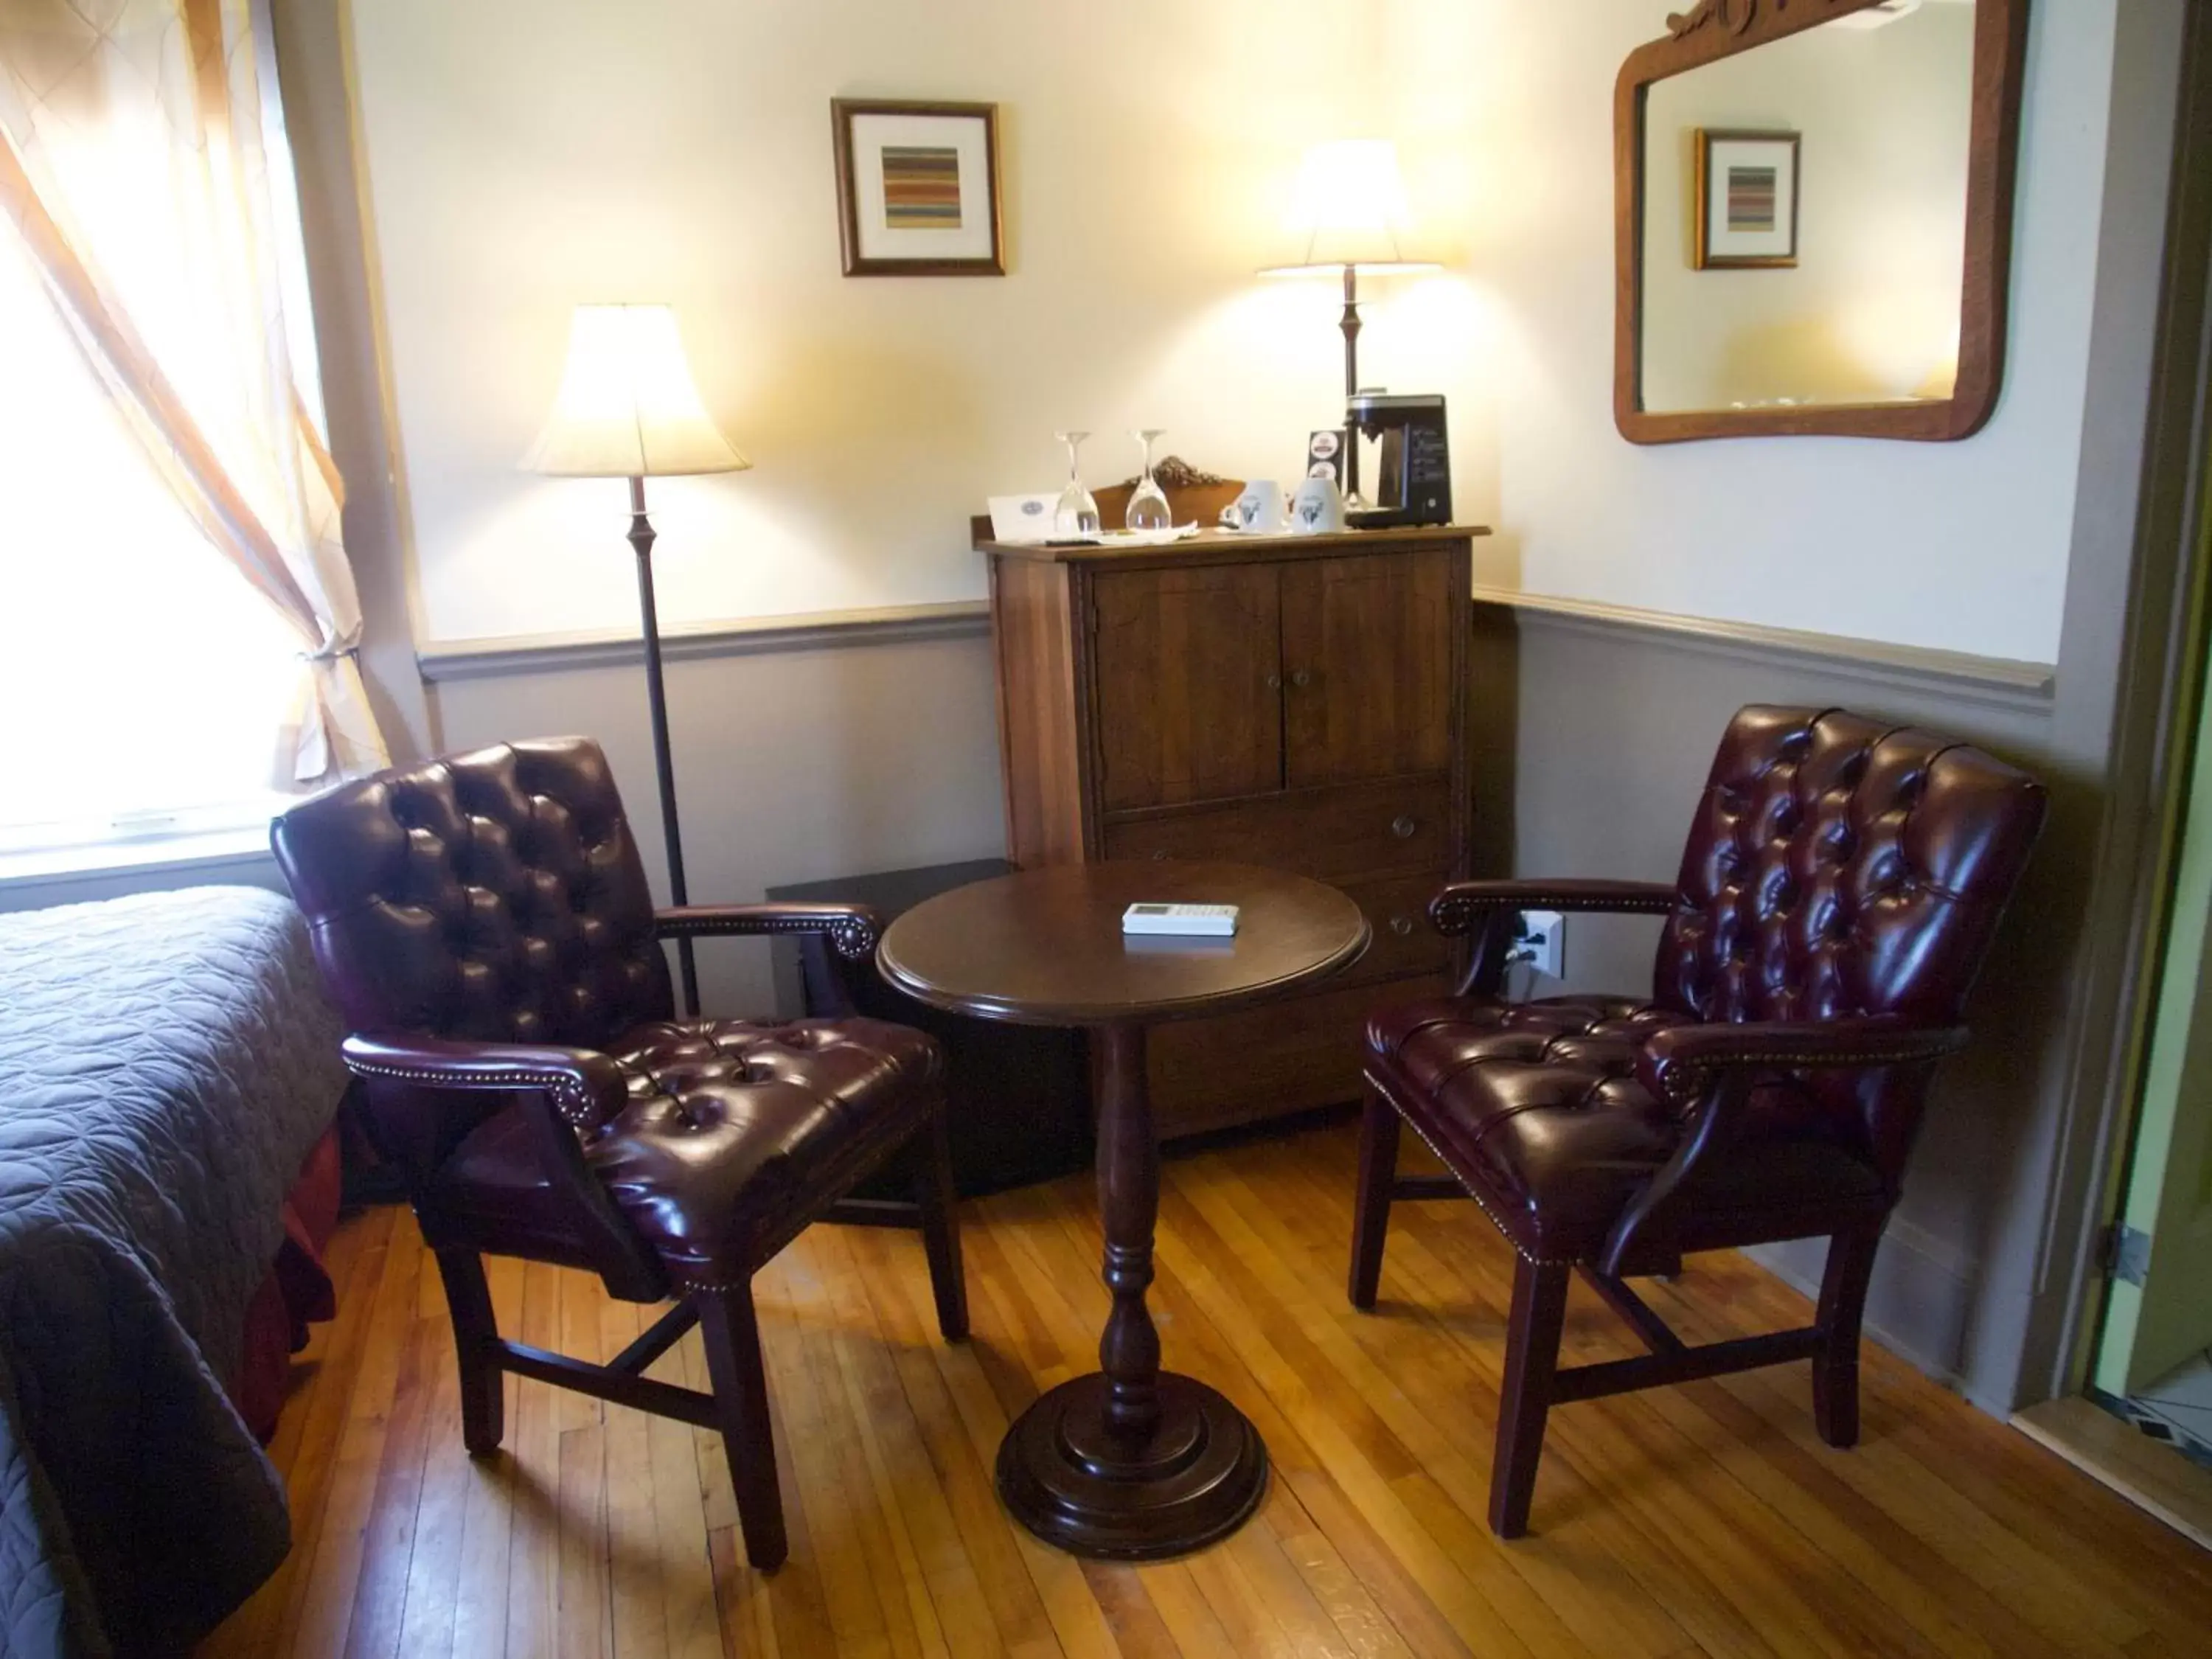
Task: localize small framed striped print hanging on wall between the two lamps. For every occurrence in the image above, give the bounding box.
[830,97,1006,276]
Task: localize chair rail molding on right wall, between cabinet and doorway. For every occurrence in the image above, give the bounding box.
[1475,584,2057,714]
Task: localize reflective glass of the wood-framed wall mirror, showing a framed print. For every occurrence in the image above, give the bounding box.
[1639,0,1975,411]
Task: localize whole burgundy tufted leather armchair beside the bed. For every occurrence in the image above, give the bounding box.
[272,737,967,1568]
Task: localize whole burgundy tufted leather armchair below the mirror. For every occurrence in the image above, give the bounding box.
[1349,708,2044,1537]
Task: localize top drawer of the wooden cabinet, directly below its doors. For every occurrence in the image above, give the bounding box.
[1104,776,1453,880]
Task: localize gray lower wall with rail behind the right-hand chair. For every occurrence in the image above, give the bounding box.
[1475,599,2062,1380]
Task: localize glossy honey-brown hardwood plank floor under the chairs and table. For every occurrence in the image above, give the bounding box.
[201,1128,2212,1659]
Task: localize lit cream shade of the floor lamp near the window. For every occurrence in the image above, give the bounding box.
[522,305,752,478]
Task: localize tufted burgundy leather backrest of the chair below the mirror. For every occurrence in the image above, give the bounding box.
[1652,706,2044,1024]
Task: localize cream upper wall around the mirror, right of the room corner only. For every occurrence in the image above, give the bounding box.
[1387,0,2119,661]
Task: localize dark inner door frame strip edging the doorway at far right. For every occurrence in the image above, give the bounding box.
[2020,4,2212,1405]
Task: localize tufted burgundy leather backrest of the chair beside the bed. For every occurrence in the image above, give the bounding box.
[272,737,672,1048]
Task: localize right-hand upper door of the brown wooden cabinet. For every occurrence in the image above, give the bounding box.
[1281,546,1458,787]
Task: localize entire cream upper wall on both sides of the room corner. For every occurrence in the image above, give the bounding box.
[354,0,2117,677]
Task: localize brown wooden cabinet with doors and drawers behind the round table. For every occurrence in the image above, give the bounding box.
[978,529,1482,1137]
